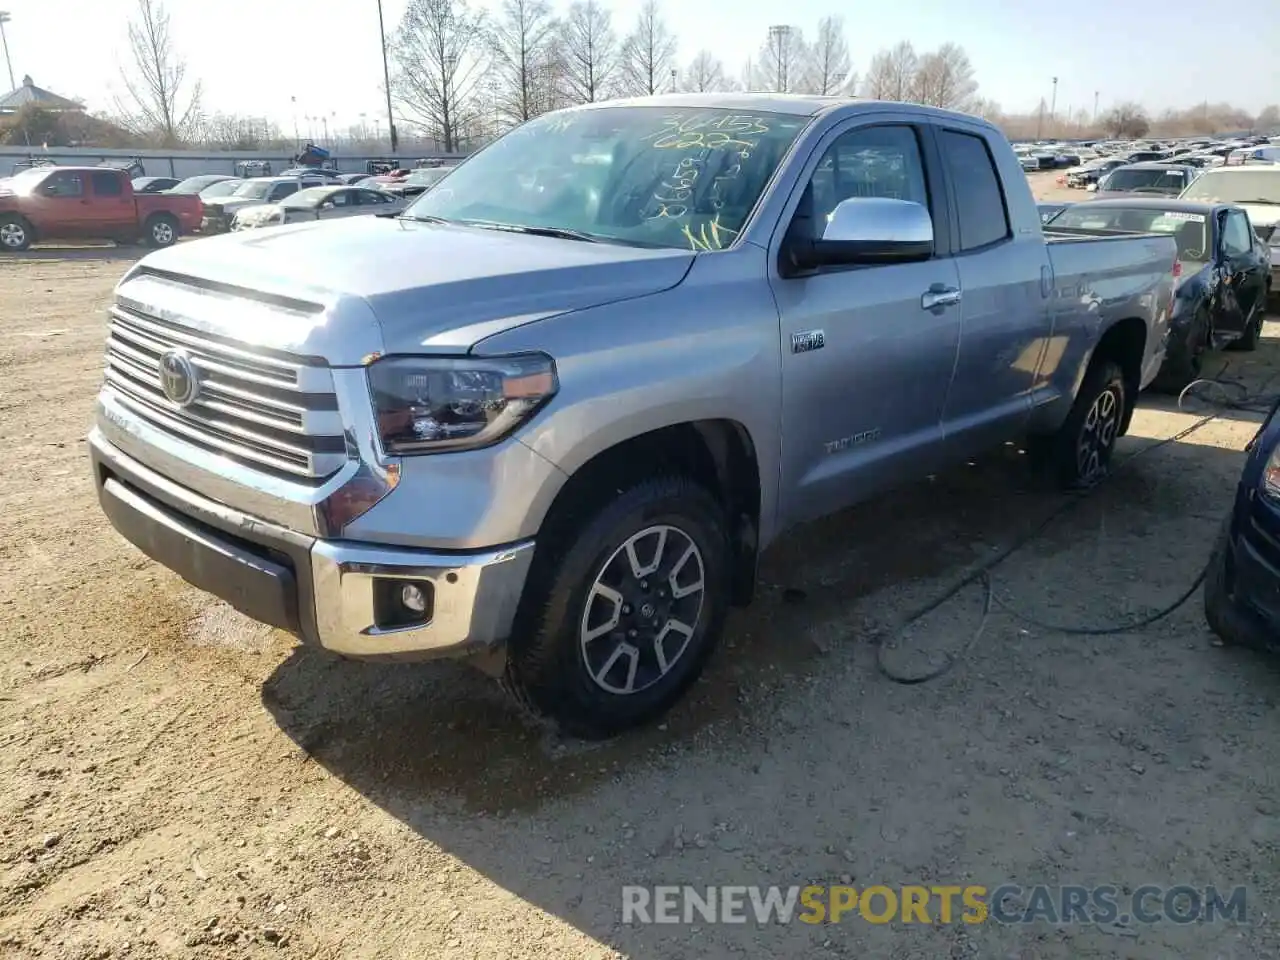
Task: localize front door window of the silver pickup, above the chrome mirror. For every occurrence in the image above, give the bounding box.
[810,125,929,224]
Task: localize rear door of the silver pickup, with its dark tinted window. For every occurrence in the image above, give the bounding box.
[938,124,1052,454]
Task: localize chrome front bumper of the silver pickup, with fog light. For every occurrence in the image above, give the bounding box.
[88,429,534,659]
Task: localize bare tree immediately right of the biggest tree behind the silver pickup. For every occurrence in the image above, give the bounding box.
[492,0,557,123]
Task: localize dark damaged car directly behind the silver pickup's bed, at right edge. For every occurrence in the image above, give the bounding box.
[1046,197,1271,392]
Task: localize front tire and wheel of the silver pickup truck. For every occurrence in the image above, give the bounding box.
[503,474,730,739]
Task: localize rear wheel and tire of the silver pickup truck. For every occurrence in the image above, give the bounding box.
[1034,360,1129,490]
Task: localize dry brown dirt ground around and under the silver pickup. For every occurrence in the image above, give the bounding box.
[0,178,1280,960]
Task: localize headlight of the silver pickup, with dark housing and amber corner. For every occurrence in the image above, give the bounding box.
[369,353,559,454]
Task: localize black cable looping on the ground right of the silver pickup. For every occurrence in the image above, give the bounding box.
[876,367,1280,686]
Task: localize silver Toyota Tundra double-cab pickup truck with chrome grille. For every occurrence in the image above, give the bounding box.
[91,95,1175,736]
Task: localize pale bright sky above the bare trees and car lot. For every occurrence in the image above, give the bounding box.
[0,0,1280,137]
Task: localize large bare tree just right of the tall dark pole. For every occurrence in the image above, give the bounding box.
[392,0,488,154]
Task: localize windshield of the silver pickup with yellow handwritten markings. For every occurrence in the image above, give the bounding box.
[407,106,809,250]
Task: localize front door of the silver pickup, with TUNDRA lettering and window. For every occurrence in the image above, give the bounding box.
[771,120,960,524]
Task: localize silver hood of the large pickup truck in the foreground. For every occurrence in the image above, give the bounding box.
[118,216,694,365]
